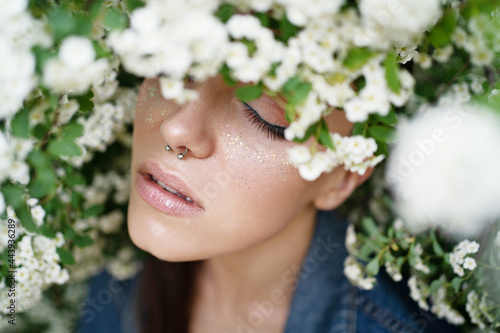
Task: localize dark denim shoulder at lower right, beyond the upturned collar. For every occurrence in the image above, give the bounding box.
[357,270,459,333]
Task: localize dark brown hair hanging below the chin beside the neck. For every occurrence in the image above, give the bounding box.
[135,256,201,333]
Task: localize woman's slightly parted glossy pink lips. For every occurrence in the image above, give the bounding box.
[135,161,204,216]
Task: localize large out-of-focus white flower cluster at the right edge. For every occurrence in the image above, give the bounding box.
[386,103,500,238]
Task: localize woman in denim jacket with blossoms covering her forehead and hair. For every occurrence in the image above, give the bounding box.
[81,77,455,333]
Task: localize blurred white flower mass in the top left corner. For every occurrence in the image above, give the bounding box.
[0,0,38,120]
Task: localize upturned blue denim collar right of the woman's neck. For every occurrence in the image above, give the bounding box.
[285,211,356,333]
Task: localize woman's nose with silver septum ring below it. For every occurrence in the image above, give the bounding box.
[160,82,215,159]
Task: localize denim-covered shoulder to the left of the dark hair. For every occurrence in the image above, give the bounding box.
[76,270,141,333]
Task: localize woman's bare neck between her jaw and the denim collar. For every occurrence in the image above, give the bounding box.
[199,206,316,311]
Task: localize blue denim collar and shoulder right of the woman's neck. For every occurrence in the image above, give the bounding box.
[302,211,458,333]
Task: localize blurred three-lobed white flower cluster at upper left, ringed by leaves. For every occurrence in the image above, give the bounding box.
[43,36,109,94]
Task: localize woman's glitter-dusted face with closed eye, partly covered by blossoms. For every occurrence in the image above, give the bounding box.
[128,77,350,261]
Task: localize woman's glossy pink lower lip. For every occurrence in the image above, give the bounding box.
[135,174,204,216]
